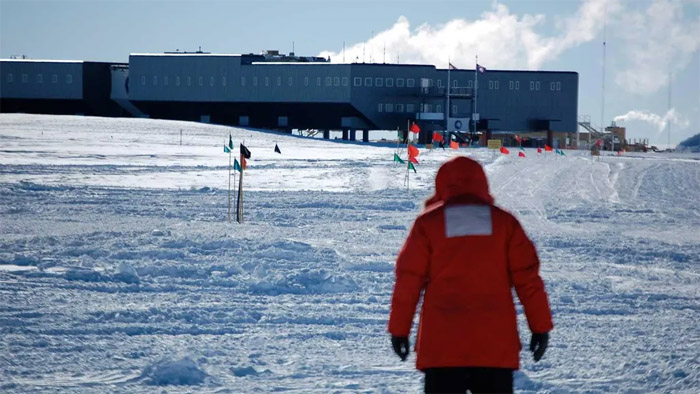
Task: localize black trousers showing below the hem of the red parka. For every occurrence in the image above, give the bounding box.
[424,367,513,394]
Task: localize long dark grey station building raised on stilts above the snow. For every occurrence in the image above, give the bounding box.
[0,52,578,142]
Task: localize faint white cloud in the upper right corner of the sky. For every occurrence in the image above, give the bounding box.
[615,0,700,94]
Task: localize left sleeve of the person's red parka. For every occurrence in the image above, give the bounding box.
[389,220,430,337]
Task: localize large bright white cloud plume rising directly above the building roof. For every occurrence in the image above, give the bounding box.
[320,0,620,70]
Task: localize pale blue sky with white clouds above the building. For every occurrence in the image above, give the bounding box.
[0,0,700,145]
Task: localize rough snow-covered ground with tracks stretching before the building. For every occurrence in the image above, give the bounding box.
[0,114,700,393]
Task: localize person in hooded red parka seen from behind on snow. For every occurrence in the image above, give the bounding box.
[389,156,553,393]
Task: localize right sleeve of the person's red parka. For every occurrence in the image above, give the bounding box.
[508,218,554,333]
